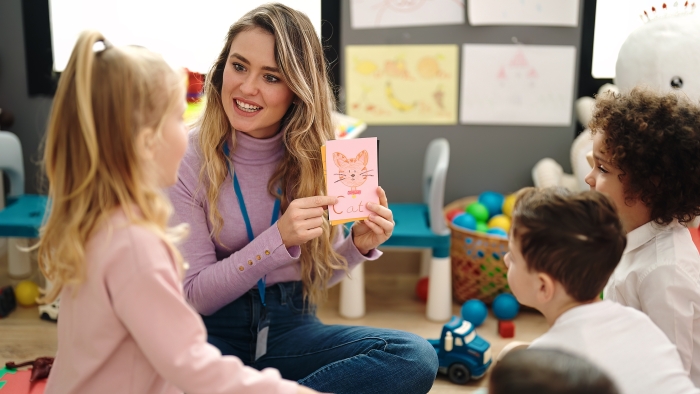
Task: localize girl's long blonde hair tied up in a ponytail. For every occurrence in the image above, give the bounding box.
[37,31,186,302]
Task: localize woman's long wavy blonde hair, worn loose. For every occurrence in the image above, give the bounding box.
[197,3,347,304]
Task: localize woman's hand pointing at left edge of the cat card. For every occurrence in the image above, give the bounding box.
[277,196,338,248]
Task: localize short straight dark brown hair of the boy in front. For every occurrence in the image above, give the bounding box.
[512,188,627,302]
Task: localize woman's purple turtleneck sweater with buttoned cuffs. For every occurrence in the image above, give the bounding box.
[168,131,381,315]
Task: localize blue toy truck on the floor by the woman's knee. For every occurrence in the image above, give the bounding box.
[428,316,491,384]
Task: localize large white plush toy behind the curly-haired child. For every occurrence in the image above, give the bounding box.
[532,2,700,191]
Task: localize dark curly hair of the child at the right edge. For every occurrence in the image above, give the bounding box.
[588,88,700,225]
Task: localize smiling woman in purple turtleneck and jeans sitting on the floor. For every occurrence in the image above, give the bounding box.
[170,4,438,393]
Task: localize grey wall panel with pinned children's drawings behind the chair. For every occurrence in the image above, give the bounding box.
[340,0,583,203]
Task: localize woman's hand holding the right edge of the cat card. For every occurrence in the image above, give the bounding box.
[352,187,394,254]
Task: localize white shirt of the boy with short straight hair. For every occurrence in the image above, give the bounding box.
[530,301,700,394]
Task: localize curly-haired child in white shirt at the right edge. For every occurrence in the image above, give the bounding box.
[586,89,700,386]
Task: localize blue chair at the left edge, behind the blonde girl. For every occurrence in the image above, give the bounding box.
[0,131,47,278]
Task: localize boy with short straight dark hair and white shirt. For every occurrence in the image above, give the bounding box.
[505,188,700,394]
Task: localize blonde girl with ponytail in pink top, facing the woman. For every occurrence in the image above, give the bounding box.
[39,31,318,393]
